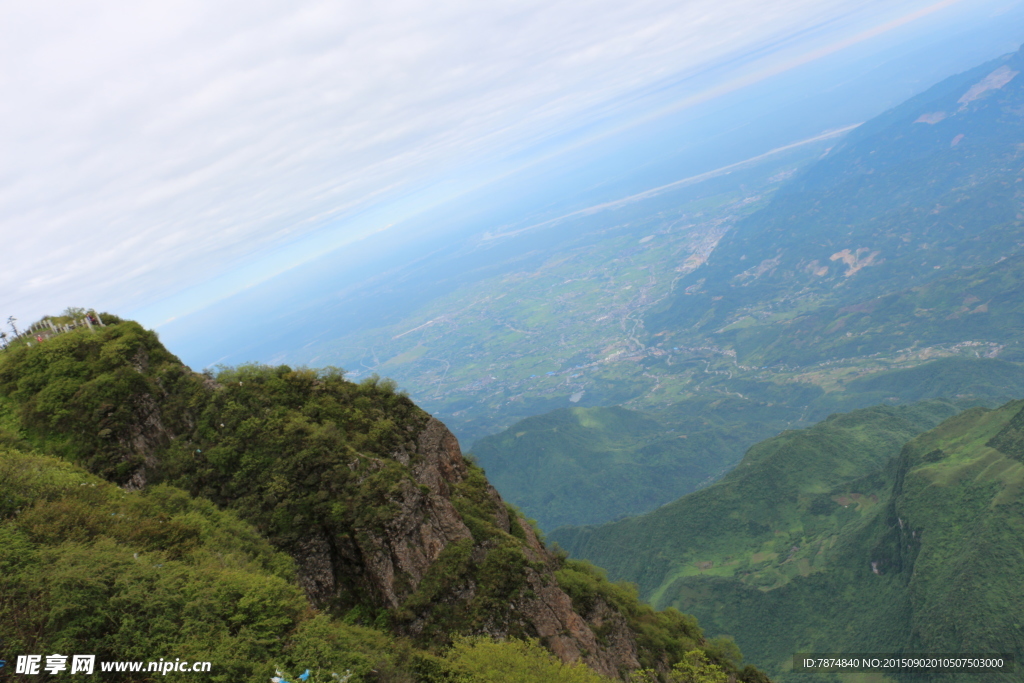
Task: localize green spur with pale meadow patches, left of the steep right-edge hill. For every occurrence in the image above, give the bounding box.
[549,400,956,603]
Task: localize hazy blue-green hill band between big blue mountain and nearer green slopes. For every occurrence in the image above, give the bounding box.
[473,357,1024,531]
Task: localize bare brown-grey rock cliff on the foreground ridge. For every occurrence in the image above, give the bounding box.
[293,419,640,677]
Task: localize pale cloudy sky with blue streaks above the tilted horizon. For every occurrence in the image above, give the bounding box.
[0,0,1024,327]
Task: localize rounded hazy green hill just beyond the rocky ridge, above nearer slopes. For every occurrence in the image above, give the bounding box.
[473,400,786,529]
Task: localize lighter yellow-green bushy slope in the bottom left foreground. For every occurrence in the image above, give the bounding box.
[0,449,403,681]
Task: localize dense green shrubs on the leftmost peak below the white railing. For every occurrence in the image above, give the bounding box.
[0,313,198,483]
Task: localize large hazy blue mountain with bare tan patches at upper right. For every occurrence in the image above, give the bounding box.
[647,44,1024,366]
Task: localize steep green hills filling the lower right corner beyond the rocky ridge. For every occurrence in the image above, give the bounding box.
[553,401,1024,681]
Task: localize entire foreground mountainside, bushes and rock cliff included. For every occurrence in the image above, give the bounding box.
[0,321,764,681]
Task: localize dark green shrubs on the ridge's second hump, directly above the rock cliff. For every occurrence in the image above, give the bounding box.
[160,366,427,565]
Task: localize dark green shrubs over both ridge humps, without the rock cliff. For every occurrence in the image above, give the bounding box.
[0,321,427,606]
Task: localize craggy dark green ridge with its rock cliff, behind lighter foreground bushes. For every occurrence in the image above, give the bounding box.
[0,315,770,677]
